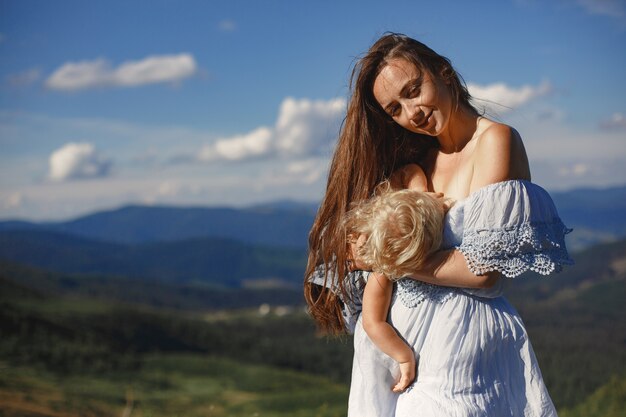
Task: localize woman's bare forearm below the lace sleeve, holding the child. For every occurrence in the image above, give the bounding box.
[411,249,500,288]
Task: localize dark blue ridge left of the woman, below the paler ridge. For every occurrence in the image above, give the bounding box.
[0,230,306,286]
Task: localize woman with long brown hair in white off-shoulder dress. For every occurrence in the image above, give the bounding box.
[305,34,571,417]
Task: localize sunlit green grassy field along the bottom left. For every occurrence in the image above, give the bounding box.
[0,354,347,417]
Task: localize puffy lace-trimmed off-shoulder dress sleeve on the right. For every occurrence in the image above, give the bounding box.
[457,180,574,278]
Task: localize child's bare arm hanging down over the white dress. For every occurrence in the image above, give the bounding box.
[362,272,415,392]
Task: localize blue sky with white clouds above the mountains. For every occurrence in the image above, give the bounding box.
[0,0,626,220]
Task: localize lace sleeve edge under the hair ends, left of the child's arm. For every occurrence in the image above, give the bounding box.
[309,265,369,334]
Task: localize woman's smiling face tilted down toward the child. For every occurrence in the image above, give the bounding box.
[373,58,452,136]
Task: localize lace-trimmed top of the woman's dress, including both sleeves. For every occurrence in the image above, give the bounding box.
[311,180,573,329]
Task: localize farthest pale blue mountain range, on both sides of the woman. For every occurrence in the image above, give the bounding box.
[0,186,626,251]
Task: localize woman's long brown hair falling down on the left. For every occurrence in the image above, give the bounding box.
[304,33,471,334]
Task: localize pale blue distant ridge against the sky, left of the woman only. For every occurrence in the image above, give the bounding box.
[0,202,315,248]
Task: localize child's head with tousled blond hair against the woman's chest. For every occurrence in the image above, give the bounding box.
[344,187,444,279]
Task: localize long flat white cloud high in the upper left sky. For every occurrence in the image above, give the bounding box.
[46,54,197,91]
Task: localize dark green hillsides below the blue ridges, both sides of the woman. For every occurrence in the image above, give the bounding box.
[0,237,626,417]
